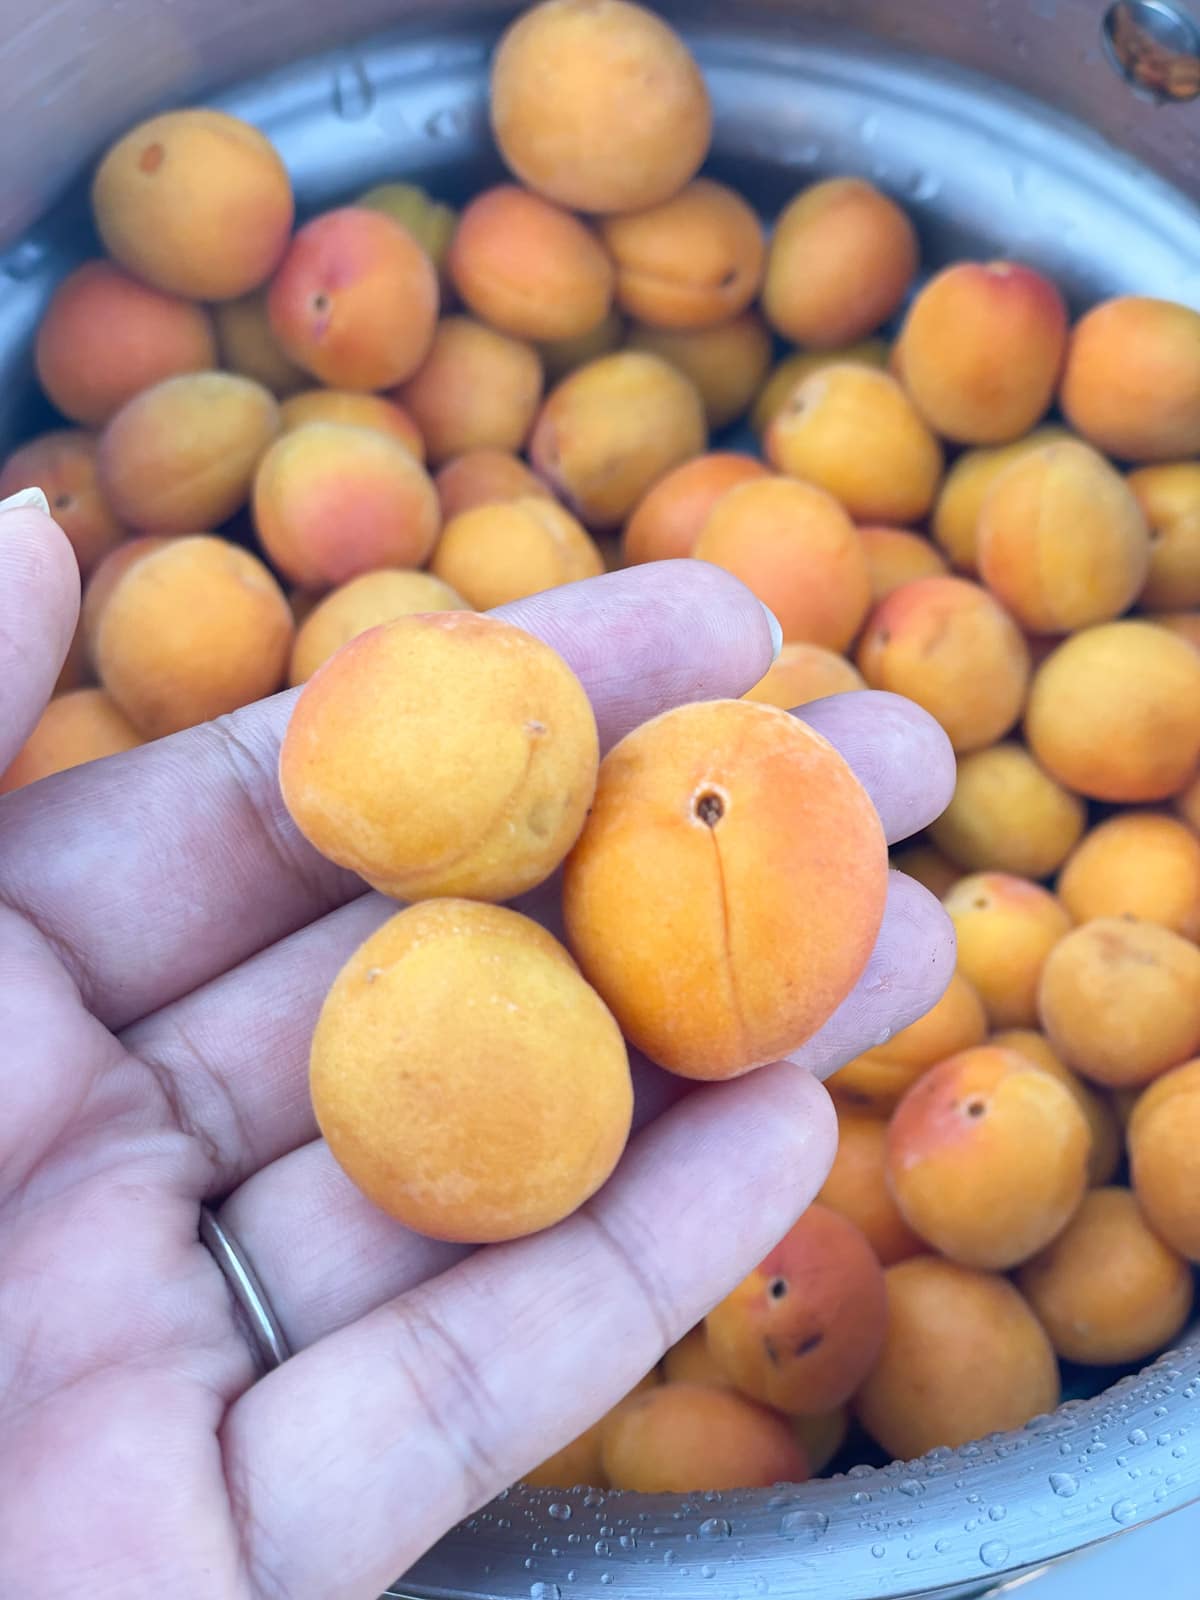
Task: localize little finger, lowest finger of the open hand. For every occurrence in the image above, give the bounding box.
[222,1064,835,1600]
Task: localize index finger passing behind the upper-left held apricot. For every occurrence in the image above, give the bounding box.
[0,562,771,1027]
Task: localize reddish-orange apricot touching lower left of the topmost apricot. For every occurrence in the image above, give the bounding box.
[448,184,614,339]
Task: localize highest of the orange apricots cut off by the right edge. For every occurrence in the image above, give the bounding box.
[1059,294,1200,461]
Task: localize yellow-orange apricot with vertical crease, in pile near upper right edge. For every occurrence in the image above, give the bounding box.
[976,440,1150,634]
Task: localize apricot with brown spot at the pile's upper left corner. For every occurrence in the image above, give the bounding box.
[91,107,294,301]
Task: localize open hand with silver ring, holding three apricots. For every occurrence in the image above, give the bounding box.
[0,510,954,1600]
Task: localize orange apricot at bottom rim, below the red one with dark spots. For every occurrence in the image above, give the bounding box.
[600,1384,810,1494]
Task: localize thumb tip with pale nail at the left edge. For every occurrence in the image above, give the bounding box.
[0,490,78,773]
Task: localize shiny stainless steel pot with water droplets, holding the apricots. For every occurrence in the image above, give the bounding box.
[0,0,1200,1600]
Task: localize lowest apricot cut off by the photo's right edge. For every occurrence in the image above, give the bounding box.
[1126,1059,1200,1261]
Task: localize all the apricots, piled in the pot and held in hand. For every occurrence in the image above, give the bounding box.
[0,0,1200,1491]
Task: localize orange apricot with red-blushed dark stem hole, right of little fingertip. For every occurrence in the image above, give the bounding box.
[886,1045,1091,1272]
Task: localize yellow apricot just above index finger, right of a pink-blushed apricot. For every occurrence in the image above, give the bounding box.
[430,496,605,611]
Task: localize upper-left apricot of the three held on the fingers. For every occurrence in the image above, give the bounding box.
[280,611,598,901]
